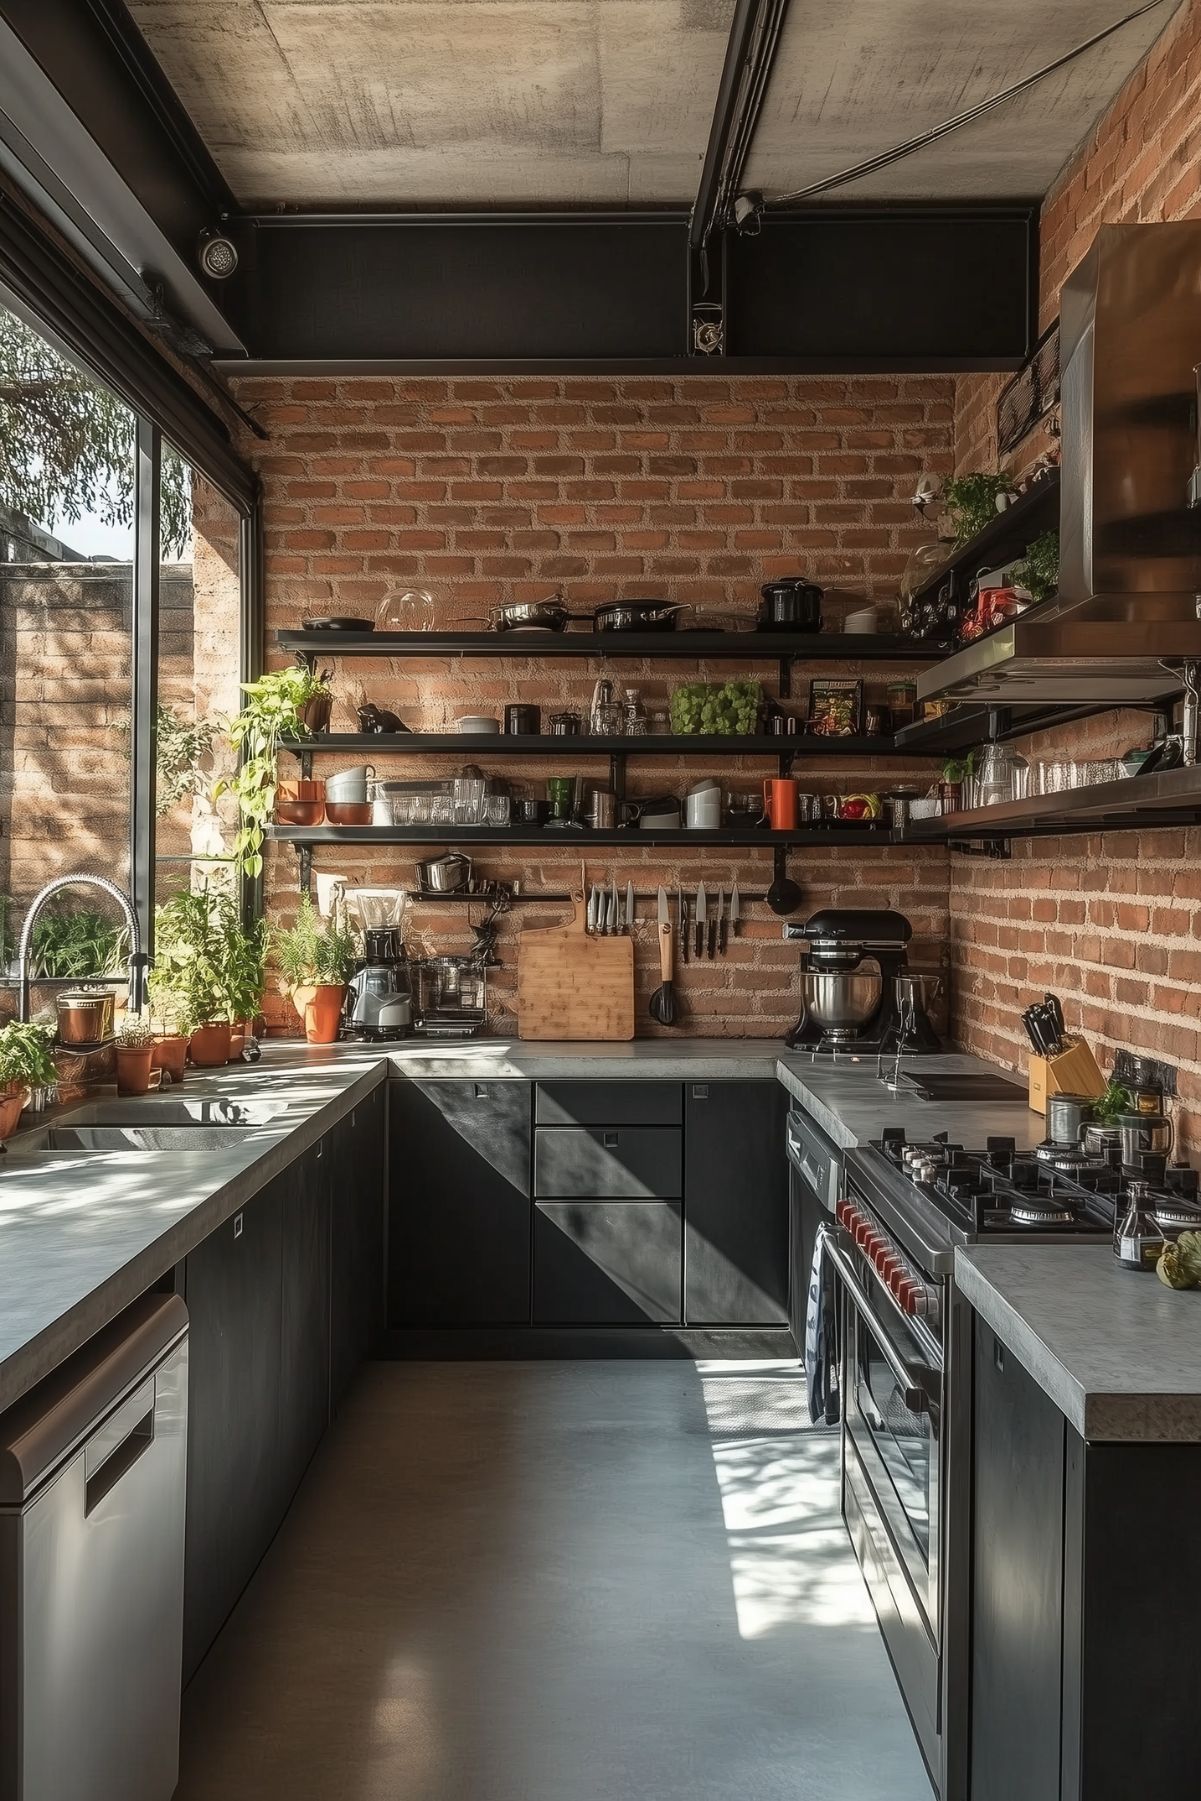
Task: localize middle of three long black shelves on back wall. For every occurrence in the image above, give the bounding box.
[284,731,915,762]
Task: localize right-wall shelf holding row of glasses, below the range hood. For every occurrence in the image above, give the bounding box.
[906,767,1201,843]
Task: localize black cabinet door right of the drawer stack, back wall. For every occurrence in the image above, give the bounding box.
[684,1082,789,1326]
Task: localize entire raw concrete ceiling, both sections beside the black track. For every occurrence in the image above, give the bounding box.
[130,0,1176,209]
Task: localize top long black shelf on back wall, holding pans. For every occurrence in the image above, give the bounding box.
[275,632,949,663]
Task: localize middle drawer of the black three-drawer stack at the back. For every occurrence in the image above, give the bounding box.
[533,1126,684,1201]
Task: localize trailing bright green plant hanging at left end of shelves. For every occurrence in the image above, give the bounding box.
[212,663,333,875]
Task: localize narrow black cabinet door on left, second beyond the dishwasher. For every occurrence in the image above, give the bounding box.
[275,1135,333,1520]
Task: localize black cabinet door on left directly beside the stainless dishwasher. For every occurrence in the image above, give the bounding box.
[184,1171,292,1680]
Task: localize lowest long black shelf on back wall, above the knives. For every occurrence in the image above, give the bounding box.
[266,819,895,850]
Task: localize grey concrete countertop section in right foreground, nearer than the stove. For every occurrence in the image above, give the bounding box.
[954,1244,1201,1444]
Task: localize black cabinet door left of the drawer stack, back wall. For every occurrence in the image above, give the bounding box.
[389,1081,533,1326]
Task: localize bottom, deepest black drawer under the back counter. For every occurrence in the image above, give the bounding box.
[533,1199,684,1326]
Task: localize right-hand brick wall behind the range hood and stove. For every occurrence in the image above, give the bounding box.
[951,0,1201,1149]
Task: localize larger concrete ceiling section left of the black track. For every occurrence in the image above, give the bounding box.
[131,0,735,207]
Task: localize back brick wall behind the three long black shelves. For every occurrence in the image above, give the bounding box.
[238,376,953,1036]
